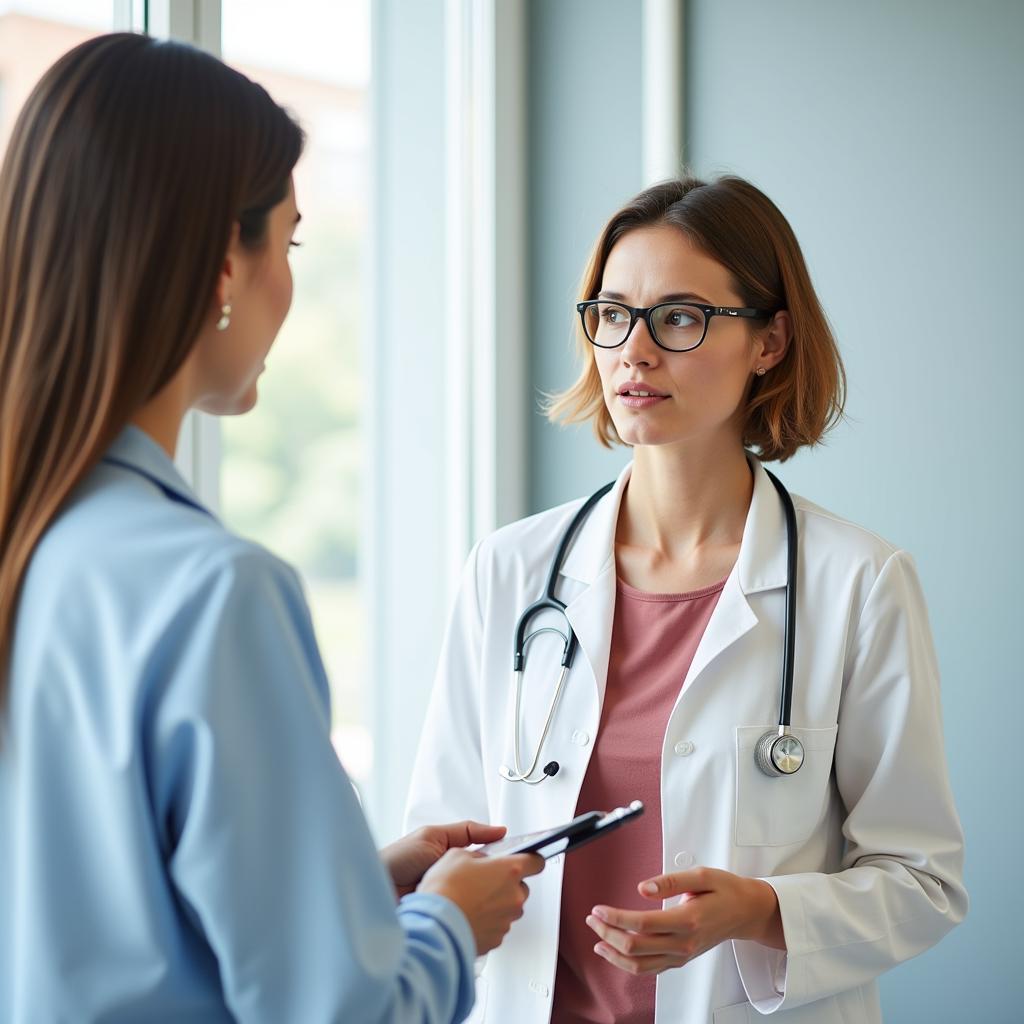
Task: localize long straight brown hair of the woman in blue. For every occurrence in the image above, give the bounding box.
[0,34,303,707]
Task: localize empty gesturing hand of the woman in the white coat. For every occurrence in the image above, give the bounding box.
[587,867,785,974]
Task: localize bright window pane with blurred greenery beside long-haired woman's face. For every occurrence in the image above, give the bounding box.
[219,0,373,785]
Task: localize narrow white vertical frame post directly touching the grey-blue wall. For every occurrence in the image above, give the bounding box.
[446,0,530,593]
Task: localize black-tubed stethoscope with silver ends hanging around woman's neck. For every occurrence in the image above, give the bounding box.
[499,470,804,785]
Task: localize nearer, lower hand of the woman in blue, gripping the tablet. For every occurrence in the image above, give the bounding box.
[419,850,544,955]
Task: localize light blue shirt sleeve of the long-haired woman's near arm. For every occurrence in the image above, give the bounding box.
[144,543,475,1024]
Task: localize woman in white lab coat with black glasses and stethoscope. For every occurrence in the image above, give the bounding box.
[409,178,967,1024]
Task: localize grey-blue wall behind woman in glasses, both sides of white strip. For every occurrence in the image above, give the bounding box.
[530,0,1024,1024]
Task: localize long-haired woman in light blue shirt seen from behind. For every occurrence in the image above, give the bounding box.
[0,35,543,1024]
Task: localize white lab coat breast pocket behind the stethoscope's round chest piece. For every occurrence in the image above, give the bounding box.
[736,725,839,846]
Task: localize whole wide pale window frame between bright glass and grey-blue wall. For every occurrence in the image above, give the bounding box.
[367,0,530,841]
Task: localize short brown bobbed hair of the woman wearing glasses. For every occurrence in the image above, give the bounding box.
[546,176,846,462]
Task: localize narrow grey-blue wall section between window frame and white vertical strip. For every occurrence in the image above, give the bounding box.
[528,0,641,499]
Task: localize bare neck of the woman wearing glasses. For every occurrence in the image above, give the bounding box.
[616,439,754,558]
